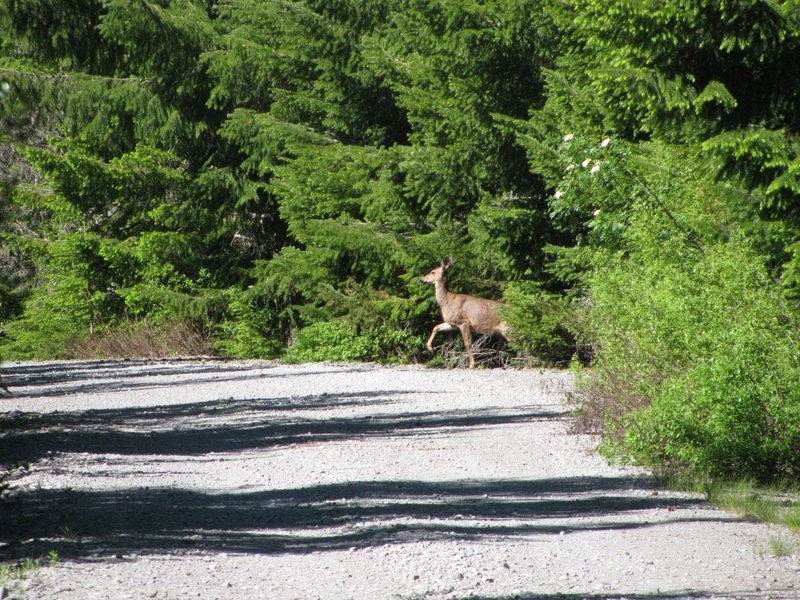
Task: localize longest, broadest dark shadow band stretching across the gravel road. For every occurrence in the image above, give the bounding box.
[0,477,726,560]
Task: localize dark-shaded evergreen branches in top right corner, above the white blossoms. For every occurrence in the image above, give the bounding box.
[556,0,800,141]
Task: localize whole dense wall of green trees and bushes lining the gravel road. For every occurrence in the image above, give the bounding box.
[0,0,800,480]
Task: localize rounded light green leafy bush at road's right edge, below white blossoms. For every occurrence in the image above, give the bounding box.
[587,223,800,480]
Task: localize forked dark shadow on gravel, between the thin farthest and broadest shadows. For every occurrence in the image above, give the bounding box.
[0,390,563,465]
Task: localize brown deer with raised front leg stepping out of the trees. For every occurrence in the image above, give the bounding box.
[422,256,511,369]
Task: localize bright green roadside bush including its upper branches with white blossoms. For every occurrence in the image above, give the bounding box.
[553,140,800,479]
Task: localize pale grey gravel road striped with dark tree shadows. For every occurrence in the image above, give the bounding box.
[0,360,800,600]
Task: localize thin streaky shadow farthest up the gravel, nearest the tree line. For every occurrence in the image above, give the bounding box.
[0,359,369,398]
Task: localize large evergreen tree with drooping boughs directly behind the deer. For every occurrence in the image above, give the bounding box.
[216,2,560,358]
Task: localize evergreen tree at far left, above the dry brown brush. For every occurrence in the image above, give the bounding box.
[2,2,249,356]
